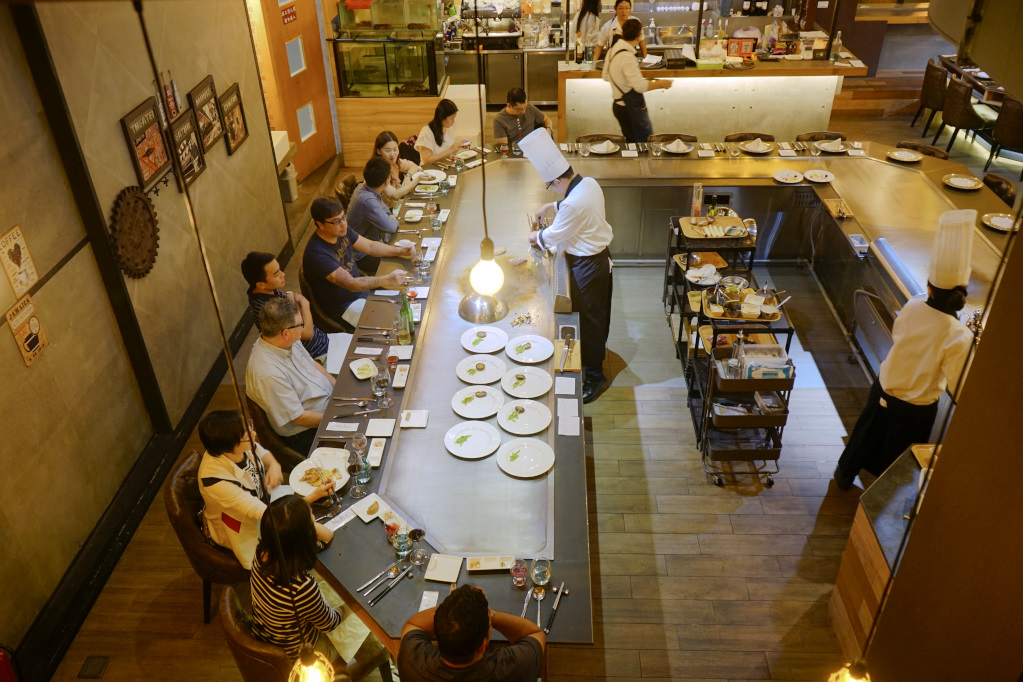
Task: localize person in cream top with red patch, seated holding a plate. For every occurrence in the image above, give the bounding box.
[198,410,333,570]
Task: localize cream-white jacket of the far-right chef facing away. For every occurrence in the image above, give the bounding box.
[878,299,973,405]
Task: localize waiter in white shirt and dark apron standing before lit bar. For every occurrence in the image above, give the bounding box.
[604,19,671,142]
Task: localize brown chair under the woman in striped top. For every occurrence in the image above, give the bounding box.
[220,587,392,682]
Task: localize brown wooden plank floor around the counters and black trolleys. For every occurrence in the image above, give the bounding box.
[49,109,1019,682]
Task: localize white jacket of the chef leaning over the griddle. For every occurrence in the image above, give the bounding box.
[536,176,615,256]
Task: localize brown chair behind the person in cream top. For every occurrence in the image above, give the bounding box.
[164,451,249,624]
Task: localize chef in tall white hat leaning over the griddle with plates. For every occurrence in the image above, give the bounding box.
[519,130,615,403]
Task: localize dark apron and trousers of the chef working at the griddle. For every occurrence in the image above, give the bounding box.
[565,246,614,378]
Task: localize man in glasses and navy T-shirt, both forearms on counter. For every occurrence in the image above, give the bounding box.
[302,198,412,326]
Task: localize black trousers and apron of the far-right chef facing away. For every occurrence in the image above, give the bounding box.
[838,379,938,481]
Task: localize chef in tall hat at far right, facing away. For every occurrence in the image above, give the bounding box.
[835,210,977,490]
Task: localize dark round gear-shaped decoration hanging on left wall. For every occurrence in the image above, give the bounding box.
[110,186,160,279]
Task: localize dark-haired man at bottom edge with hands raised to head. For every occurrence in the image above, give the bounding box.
[398,585,547,682]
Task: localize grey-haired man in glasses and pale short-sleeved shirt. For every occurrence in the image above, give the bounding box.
[246,298,333,453]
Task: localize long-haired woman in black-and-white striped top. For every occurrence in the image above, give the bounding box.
[252,495,344,666]
